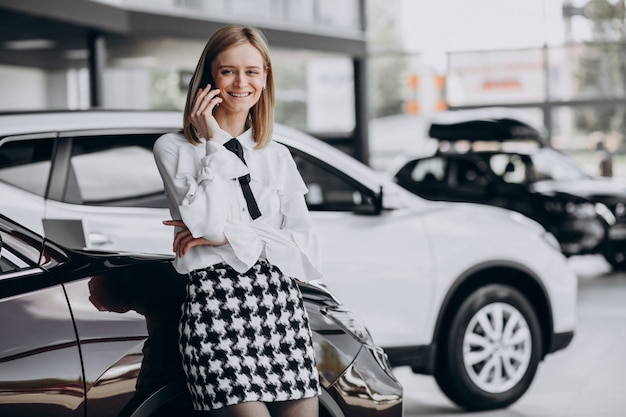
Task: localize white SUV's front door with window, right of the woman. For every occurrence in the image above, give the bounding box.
[292,149,434,347]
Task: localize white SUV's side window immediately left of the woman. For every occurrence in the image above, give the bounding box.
[70,134,167,208]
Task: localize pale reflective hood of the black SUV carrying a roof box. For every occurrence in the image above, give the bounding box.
[532,178,626,201]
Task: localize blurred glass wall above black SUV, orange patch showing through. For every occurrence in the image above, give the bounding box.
[446,42,626,177]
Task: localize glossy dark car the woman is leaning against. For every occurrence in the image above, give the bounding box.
[0,215,402,417]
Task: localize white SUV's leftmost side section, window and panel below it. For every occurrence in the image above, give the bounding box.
[0,133,56,233]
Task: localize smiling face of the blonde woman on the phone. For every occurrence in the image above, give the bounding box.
[211,42,267,115]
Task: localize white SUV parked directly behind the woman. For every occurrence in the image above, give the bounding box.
[0,111,577,410]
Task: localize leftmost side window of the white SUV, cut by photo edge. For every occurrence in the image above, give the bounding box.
[0,138,54,197]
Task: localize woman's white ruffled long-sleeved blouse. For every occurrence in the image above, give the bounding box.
[154,129,322,281]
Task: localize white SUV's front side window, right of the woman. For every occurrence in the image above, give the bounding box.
[292,149,375,212]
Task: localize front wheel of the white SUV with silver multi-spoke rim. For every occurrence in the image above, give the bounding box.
[435,284,542,410]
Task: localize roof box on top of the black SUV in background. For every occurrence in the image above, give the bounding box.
[428,108,547,146]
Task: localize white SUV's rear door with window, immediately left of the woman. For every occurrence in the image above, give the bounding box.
[44,131,173,253]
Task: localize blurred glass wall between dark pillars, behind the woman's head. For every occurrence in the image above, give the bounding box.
[97,39,356,135]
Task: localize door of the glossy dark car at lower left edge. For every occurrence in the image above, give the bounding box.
[0,219,85,417]
